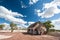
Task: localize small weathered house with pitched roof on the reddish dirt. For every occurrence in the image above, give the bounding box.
[27,21,46,35]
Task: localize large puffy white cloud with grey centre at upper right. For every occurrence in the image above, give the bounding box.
[37,0,60,18]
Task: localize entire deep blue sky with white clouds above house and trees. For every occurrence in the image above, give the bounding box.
[0,0,60,29]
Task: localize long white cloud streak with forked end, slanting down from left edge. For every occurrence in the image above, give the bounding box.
[0,6,26,24]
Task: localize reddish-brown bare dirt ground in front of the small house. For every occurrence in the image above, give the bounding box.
[0,32,59,40]
